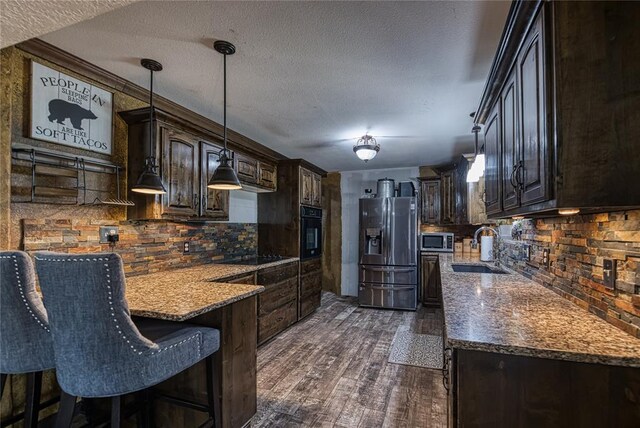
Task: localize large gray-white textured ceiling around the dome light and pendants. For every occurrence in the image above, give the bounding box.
[43,1,510,171]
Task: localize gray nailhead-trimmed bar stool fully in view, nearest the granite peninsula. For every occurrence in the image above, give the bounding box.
[35,252,220,427]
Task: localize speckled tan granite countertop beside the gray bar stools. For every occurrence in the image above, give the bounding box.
[126,258,298,321]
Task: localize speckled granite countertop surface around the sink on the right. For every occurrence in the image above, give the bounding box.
[438,253,640,367]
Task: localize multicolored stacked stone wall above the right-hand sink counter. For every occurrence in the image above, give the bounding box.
[501,210,640,338]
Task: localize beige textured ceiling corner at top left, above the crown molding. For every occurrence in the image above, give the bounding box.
[0,0,137,48]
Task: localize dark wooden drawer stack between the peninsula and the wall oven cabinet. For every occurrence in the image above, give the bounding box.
[258,262,298,345]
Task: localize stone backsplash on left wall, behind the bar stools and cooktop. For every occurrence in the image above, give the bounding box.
[22,219,258,276]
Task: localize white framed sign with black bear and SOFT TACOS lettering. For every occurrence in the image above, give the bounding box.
[30,61,113,155]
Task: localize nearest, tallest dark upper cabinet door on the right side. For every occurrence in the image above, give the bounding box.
[518,14,549,205]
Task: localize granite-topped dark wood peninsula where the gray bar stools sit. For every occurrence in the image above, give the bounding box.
[126,259,292,427]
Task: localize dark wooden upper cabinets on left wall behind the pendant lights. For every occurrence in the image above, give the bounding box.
[119,108,277,220]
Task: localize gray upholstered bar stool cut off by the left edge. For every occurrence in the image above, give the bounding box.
[0,251,55,427]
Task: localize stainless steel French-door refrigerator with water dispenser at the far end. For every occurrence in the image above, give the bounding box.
[358,197,418,310]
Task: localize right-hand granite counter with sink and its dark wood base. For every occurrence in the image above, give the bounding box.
[439,254,640,427]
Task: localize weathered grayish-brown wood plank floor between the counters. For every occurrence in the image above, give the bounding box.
[251,293,447,428]
